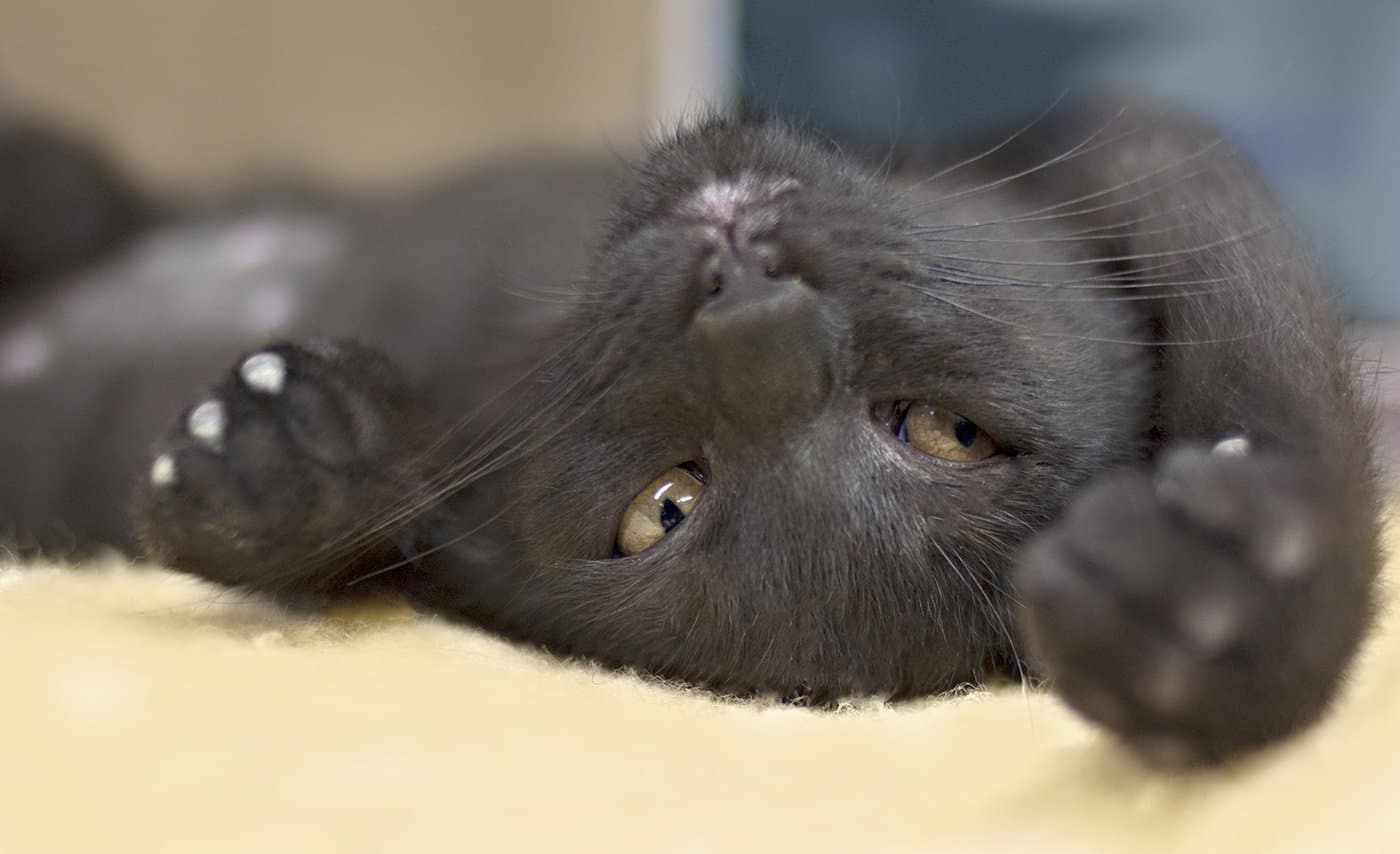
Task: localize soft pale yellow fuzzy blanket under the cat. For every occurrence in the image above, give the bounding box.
[0,520,1400,854]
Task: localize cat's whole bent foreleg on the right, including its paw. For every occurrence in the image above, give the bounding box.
[1016,102,1380,763]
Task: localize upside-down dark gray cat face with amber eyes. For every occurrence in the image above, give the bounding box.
[470,120,1151,699]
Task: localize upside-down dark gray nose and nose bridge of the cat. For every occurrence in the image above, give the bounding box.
[692,258,839,437]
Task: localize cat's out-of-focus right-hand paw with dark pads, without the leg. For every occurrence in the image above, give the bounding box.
[1016,447,1373,764]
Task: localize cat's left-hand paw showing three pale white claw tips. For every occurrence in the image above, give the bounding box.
[136,337,405,589]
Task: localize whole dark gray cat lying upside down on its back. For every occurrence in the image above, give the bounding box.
[0,99,1379,764]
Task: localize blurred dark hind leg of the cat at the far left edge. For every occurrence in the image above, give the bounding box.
[0,111,157,304]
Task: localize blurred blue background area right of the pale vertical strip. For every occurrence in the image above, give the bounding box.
[741,0,1400,318]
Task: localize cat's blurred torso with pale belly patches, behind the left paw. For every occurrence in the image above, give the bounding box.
[0,128,615,546]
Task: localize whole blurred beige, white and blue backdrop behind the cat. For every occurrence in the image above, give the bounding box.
[0,0,1400,312]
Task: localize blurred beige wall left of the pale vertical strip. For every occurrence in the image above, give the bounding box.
[0,0,654,182]
